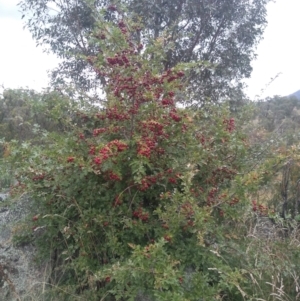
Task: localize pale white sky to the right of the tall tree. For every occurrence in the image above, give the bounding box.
[245,0,300,98]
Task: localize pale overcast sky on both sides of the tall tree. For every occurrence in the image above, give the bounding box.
[0,0,300,99]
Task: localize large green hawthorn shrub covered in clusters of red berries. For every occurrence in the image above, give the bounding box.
[11,11,253,301]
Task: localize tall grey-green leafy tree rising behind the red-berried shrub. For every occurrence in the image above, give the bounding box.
[20,0,269,103]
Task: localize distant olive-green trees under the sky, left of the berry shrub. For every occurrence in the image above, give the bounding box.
[0,89,78,142]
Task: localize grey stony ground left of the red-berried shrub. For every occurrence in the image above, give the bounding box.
[0,194,47,301]
